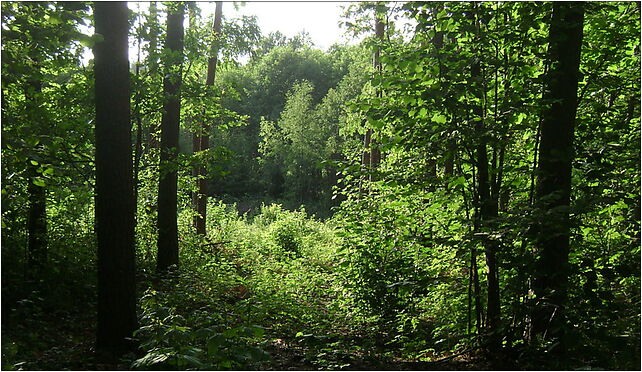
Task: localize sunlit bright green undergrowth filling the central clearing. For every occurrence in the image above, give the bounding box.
[133,203,346,369]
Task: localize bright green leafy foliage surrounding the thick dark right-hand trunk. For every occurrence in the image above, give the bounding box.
[332,3,639,366]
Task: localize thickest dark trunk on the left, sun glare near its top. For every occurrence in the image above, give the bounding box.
[94,2,137,354]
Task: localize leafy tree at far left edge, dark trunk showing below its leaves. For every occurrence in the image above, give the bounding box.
[2,3,88,279]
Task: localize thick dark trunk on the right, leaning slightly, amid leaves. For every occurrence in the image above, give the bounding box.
[531,2,584,350]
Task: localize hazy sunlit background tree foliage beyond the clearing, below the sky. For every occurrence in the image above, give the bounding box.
[211,42,367,212]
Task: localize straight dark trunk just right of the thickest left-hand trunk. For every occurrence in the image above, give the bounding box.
[156,2,185,273]
